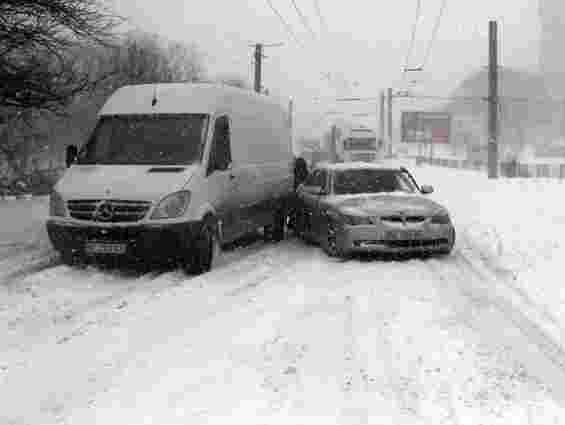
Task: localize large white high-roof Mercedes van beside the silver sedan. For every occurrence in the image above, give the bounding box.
[47,83,293,273]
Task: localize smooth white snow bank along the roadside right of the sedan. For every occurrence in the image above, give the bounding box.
[412,165,565,346]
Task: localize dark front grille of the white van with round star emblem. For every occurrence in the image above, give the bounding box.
[67,199,151,223]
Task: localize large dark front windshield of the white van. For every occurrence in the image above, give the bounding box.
[78,114,209,165]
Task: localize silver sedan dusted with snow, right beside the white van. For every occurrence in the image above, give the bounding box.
[296,162,455,256]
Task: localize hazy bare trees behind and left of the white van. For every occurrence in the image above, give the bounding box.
[0,26,204,179]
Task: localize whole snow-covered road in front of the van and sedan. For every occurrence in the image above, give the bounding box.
[0,163,565,425]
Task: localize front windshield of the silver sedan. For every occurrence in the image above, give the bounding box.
[333,169,417,195]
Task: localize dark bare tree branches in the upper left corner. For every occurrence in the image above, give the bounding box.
[0,0,120,110]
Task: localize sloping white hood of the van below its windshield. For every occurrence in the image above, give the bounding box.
[55,165,197,201]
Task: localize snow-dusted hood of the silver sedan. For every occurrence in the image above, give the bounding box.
[326,192,447,216]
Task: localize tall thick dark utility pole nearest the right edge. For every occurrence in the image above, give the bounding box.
[488,21,498,179]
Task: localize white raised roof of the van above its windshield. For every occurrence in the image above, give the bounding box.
[99,83,288,115]
